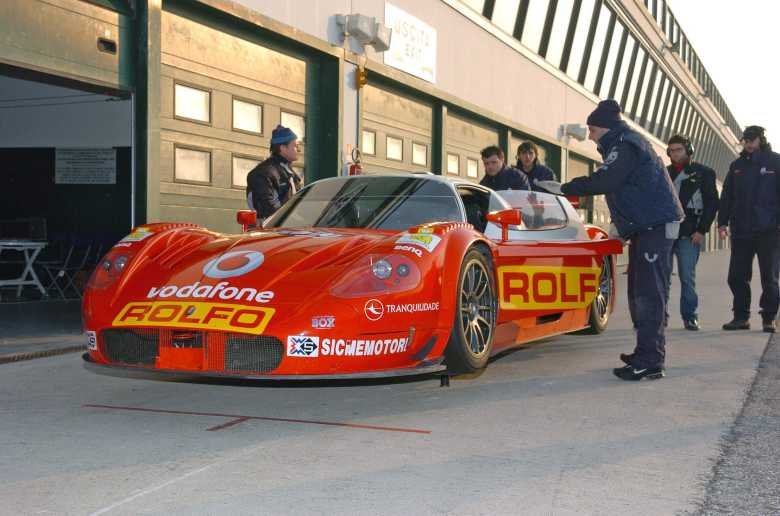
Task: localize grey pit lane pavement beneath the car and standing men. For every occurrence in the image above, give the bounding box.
[0,254,778,514]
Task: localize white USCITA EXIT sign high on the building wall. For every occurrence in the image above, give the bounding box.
[384,3,436,82]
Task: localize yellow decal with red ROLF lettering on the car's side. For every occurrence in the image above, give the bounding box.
[498,265,601,310]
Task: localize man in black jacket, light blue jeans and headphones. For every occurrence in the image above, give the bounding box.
[666,134,718,331]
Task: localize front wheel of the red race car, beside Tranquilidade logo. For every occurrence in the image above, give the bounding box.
[444,249,498,373]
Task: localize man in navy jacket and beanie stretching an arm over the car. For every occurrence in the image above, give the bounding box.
[561,100,684,381]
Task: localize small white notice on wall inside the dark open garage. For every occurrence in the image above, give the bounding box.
[54,149,116,185]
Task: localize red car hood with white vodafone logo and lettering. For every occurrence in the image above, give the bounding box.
[112,228,398,305]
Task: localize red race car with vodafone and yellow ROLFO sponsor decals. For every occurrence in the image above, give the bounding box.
[83,174,622,379]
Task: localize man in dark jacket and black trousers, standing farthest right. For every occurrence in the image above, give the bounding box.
[718,125,780,333]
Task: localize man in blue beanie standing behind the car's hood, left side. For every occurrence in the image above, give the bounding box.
[246,125,302,226]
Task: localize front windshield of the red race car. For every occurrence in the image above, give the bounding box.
[264,176,463,231]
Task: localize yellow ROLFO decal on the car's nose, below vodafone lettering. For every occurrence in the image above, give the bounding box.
[113,301,276,335]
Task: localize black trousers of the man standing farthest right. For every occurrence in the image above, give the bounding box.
[728,231,780,321]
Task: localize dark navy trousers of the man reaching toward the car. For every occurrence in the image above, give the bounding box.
[628,225,675,369]
